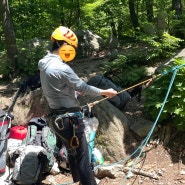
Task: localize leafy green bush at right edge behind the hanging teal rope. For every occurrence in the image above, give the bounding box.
[143,58,185,130]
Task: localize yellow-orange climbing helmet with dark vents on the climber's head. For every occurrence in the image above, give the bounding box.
[51,26,78,48]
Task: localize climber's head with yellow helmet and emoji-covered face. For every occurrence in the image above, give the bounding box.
[51,26,78,62]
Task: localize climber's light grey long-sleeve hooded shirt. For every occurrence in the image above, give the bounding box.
[38,53,100,109]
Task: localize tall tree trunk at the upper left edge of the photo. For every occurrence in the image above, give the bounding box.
[0,0,17,75]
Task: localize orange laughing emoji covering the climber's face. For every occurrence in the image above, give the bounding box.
[59,45,76,62]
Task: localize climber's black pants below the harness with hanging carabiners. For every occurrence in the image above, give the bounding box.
[49,112,97,185]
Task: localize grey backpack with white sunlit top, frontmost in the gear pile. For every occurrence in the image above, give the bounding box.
[12,145,47,185]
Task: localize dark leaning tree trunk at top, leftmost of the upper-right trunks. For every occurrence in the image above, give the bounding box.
[129,0,139,30]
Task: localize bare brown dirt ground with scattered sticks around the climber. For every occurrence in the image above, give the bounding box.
[1,57,185,185]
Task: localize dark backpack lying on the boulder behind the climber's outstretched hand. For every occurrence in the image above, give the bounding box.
[87,75,131,110]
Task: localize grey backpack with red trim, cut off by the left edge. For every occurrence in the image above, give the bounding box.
[0,110,12,174]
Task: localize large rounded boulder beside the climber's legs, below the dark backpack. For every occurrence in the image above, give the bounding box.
[79,96,128,162]
